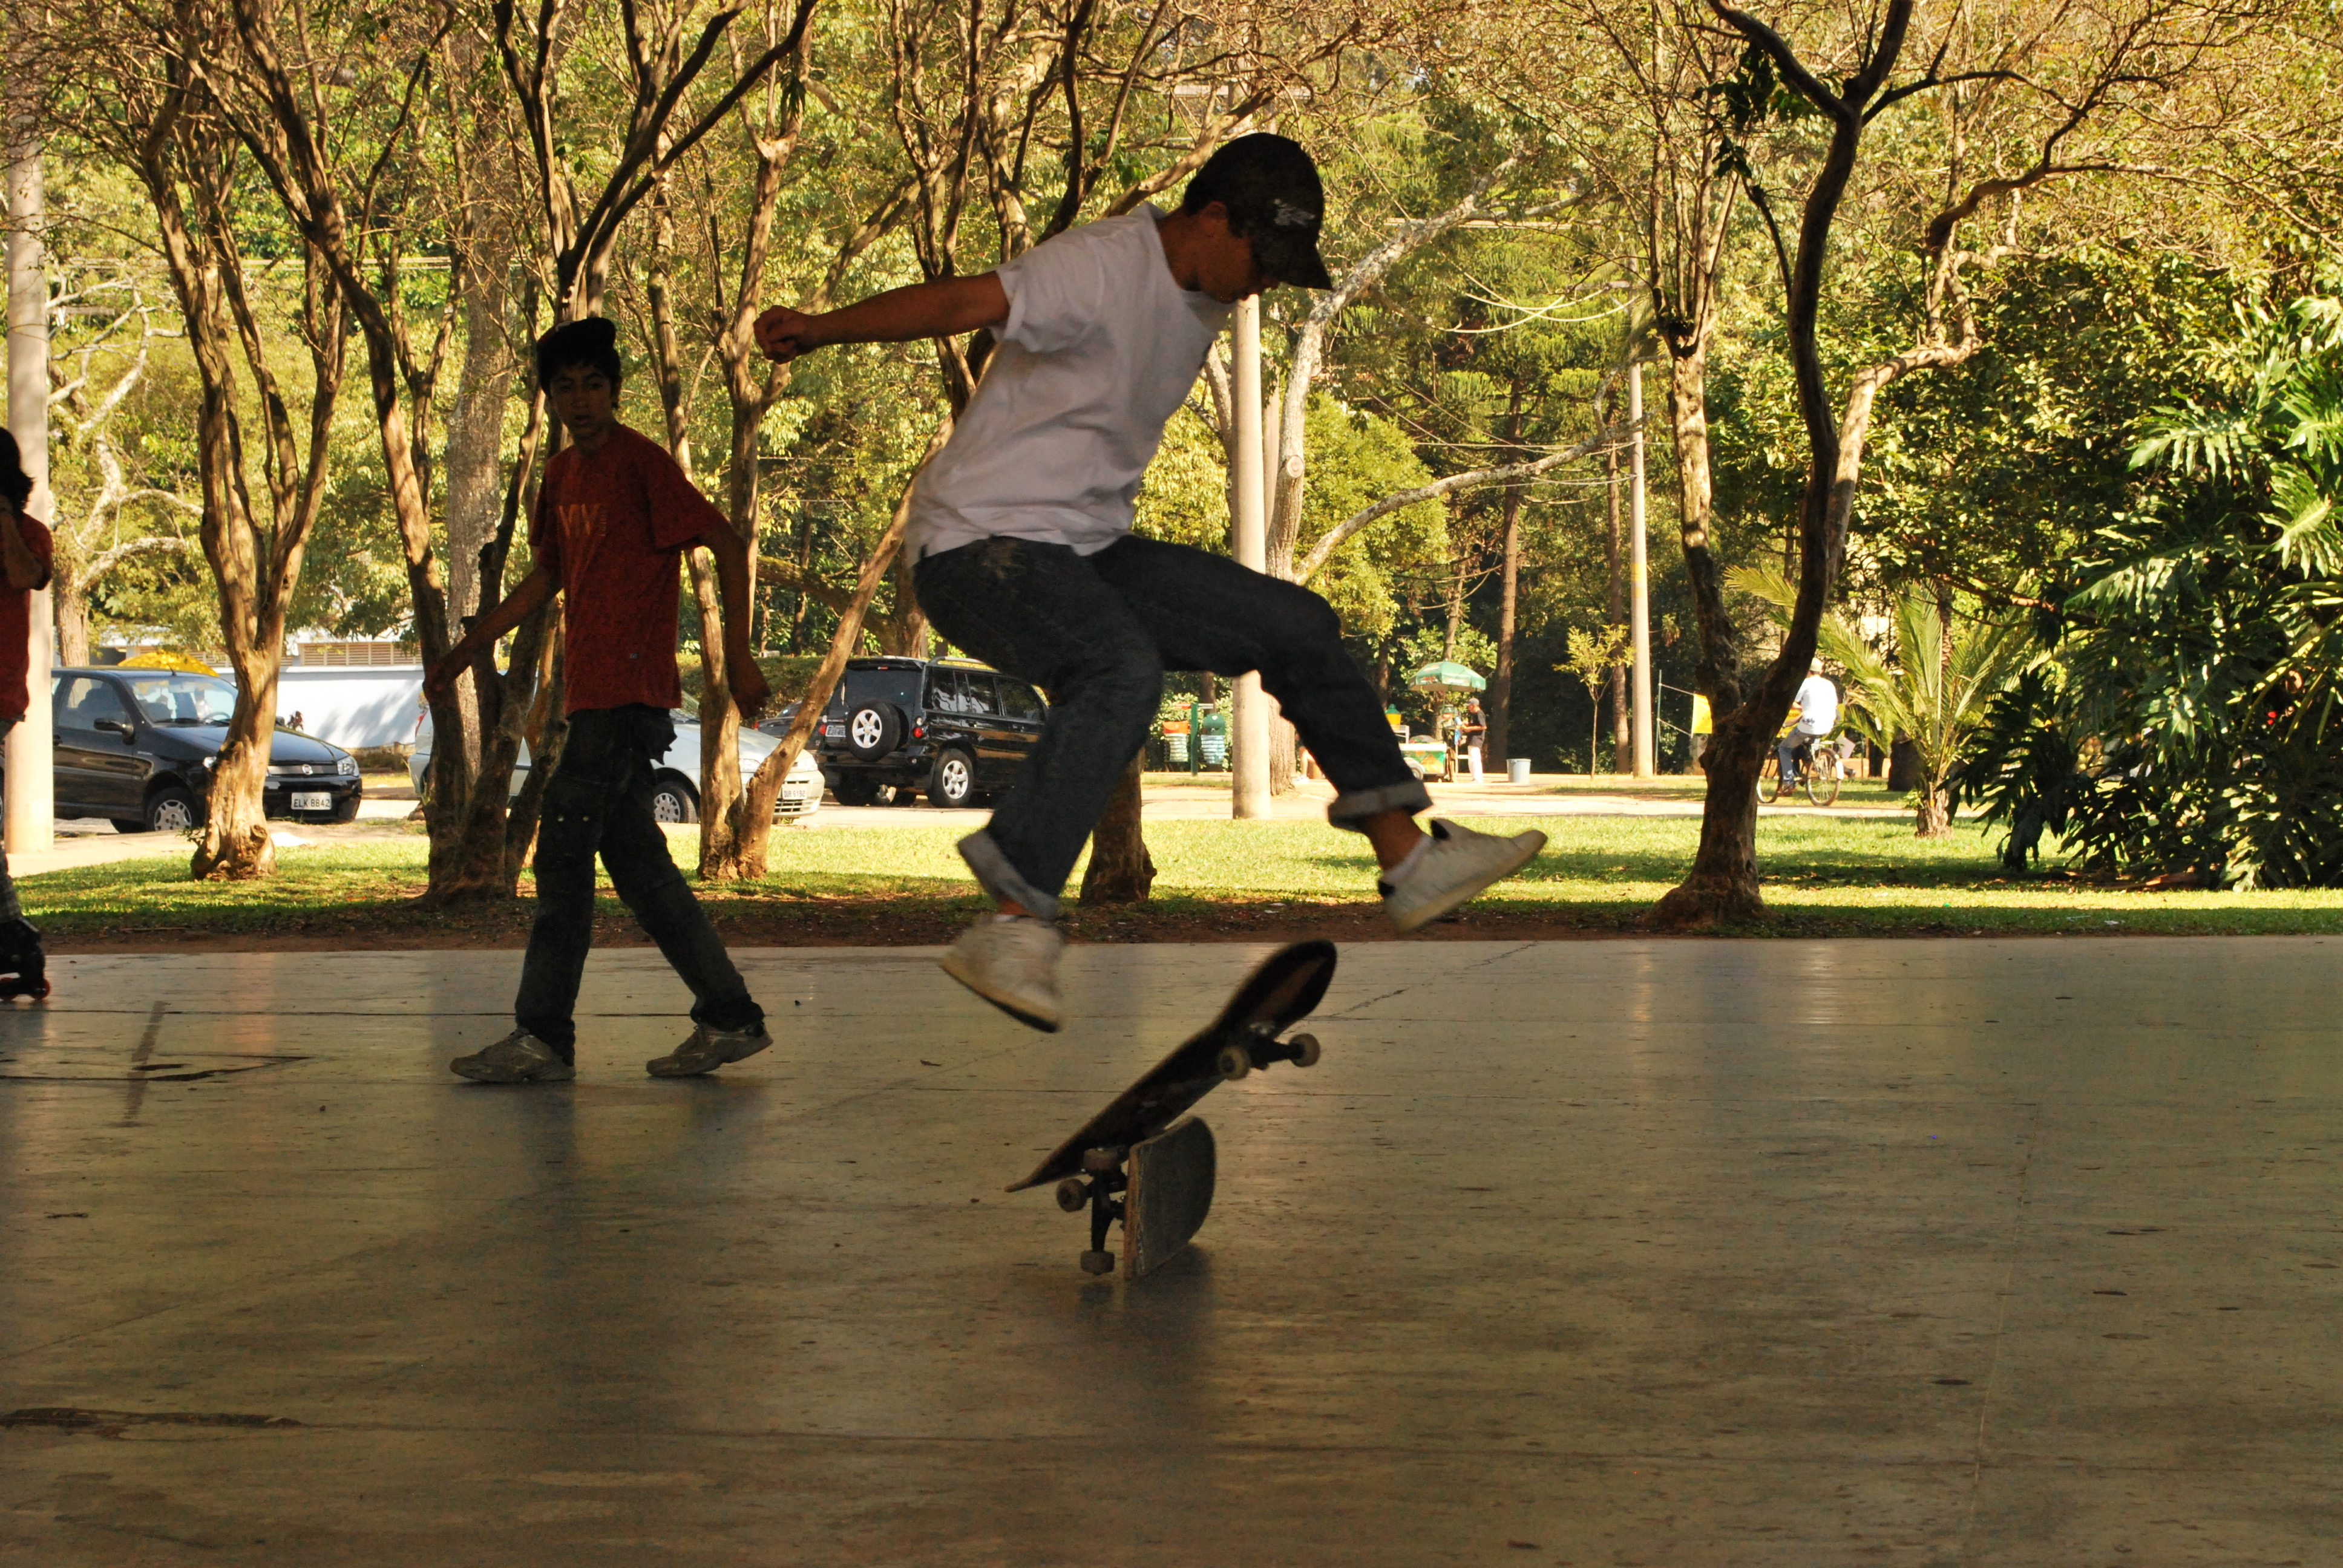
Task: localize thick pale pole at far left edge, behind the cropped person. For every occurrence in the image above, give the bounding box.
[0,107,56,855]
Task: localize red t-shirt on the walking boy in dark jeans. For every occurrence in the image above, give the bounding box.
[529,424,731,713]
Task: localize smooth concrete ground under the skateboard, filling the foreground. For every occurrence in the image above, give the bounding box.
[0,938,2343,1568]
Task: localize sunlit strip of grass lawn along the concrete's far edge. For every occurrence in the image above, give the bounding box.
[24,815,2343,949]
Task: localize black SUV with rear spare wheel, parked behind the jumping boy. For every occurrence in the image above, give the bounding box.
[813,659,1043,806]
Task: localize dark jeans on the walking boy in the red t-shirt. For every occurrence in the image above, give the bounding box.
[513,703,764,1062]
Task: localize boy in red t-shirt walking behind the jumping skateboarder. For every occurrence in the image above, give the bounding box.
[424,316,771,1083]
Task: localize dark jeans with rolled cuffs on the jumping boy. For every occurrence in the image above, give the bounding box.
[911,537,1432,919]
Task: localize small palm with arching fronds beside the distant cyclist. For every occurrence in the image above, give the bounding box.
[1729,567,2039,839]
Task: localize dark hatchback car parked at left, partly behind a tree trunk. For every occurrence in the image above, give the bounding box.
[49,668,361,832]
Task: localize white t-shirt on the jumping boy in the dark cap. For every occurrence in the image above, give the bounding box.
[905,206,1230,560]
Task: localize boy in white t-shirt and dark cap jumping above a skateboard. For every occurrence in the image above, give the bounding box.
[757,136,1544,1029]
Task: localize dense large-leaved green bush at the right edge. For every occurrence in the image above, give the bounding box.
[2062,282,2343,886]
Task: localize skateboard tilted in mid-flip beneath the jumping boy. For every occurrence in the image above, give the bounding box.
[1010,942,1335,1279]
